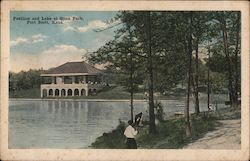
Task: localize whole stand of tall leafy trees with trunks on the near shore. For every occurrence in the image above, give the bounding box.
[90,11,240,135]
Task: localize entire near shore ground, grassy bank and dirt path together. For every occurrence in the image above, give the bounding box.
[90,108,241,150]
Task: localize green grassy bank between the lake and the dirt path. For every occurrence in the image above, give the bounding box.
[91,109,240,149]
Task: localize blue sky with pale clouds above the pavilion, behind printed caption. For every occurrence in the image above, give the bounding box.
[9,11,120,72]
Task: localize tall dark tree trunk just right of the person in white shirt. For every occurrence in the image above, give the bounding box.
[146,11,156,134]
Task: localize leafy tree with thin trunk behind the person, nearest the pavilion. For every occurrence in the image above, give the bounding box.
[89,18,141,121]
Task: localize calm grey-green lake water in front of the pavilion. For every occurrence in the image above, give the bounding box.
[9,97,228,149]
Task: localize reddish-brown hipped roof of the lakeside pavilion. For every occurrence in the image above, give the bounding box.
[44,61,101,75]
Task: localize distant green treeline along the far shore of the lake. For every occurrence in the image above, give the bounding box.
[9,64,230,93]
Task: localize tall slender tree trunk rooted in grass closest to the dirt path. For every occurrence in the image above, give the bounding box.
[185,12,193,137]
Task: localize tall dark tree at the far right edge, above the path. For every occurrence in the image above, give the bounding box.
[214,11,241,107]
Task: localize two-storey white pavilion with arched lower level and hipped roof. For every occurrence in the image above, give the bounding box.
[41,61,104,98]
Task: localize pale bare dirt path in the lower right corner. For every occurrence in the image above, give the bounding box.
[183,119,241,149]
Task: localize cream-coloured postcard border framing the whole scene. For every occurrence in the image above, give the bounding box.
[0,1,250,161]
